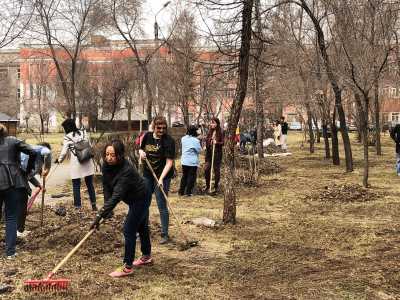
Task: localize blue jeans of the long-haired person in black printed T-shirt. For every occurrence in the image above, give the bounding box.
[143,176,171,237]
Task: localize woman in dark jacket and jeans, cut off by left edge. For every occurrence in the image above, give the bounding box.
[0,124,36,259]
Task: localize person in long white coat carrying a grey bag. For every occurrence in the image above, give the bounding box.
[54,119,97,211]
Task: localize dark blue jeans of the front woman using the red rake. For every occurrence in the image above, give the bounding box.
[124,186,151,266]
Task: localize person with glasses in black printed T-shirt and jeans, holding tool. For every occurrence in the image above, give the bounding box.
[139,116,175,244]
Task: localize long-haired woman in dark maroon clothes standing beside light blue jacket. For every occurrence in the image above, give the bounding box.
[204,117,224,193]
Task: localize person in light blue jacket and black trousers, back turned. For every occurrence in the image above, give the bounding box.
[178,125,201,196]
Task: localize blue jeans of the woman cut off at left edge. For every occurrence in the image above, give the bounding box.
[0,188,26,256]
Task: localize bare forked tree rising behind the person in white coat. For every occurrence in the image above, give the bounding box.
[30,0,104,118]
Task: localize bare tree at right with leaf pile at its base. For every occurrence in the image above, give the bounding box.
[330,1,399,187]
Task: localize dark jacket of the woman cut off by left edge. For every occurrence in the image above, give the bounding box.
[0,136,36,191]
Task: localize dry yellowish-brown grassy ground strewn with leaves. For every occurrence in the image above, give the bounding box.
[0,132,400,299]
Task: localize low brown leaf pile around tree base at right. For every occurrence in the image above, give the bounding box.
[306,184,380,203]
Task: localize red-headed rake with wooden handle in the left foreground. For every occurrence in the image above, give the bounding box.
[24,223,96,292]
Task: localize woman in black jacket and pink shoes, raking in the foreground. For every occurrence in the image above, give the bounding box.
[91,140,153,277]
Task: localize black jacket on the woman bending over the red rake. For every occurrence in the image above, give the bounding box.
[99,159,147,218]
